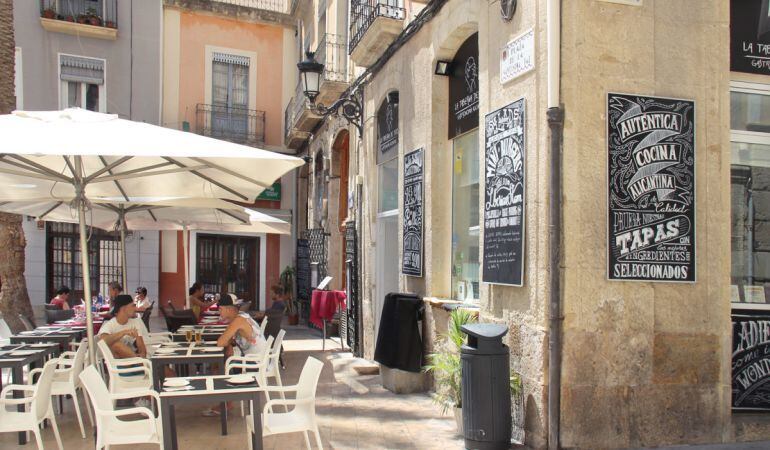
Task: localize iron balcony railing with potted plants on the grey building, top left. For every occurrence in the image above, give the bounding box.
[40,0,118,28]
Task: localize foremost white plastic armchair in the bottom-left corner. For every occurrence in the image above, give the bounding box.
[0,359,62,450]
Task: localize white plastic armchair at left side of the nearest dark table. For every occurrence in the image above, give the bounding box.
[80,366,163,450]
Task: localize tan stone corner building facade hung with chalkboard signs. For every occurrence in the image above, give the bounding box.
[290,0,770,448]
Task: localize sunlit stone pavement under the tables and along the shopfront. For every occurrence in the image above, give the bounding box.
[0,326,462,450]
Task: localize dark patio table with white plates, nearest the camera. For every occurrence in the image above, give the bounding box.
[160,375,262,450]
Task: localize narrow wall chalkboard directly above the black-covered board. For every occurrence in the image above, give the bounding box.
[401,149,424,277]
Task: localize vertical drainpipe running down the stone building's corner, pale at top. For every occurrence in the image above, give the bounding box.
[546,0,564,450]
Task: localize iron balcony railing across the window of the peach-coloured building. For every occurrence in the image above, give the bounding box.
[195,103,265,145]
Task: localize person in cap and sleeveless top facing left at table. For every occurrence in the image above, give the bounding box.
[203,294,267,417]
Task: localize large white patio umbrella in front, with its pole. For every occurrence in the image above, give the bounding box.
[0,108,303,357]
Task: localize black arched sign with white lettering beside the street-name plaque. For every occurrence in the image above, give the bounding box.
[449,33,479,139]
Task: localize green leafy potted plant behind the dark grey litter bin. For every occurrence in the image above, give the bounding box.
[424,308,521,435]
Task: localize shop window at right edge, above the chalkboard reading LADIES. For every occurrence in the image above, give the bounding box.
[730,82,770,308]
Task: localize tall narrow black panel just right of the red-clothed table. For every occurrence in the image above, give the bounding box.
[342,222,362,356]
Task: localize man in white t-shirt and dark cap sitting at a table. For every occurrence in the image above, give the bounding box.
[99,294,149,359]
